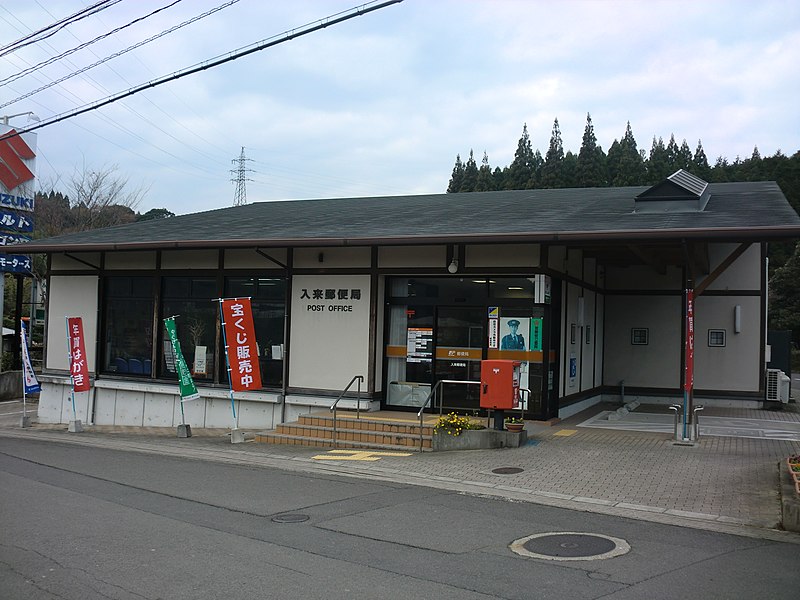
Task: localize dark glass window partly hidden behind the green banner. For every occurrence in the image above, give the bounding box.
[159,277,219,381]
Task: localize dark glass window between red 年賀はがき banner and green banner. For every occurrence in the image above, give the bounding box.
[103,277,153,377]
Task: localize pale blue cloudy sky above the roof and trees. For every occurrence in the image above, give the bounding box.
[0,0,800,214]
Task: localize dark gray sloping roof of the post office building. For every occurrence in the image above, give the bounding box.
[19,182,800,252]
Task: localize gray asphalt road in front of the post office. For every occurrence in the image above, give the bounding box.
[0,437,800,600]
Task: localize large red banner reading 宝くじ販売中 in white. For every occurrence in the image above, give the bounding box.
[220,298,261,392]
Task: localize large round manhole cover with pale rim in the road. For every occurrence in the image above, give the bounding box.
[510,531,631,560]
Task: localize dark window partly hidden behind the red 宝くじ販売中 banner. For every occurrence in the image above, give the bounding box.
[221,277,286,387]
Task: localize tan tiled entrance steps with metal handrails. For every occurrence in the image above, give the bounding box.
[255,413,433,452]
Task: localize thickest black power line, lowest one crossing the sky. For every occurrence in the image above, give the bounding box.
[0,0,403,140]
